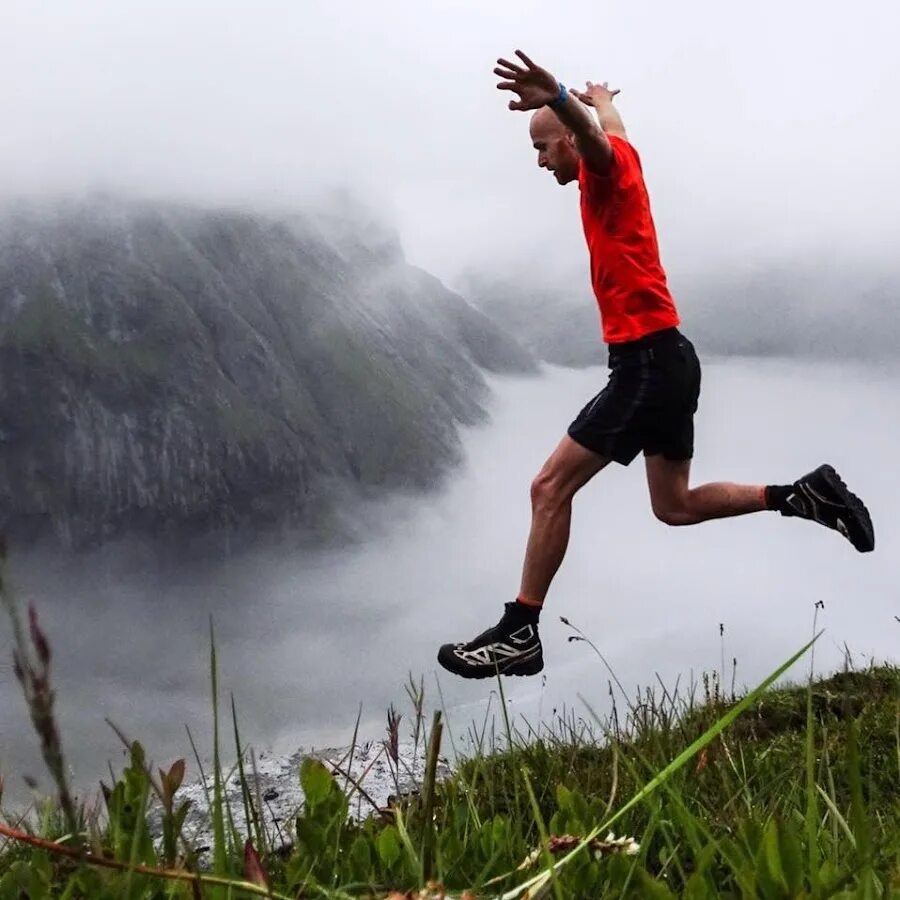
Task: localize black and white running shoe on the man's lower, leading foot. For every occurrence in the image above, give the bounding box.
[438,603,544,678]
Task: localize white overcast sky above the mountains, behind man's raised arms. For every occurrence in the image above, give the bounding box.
[0,0,900,280]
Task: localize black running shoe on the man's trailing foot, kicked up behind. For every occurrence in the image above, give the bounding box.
[781,465,875,553]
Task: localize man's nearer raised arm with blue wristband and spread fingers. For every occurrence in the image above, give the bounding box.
[494,50,612,175]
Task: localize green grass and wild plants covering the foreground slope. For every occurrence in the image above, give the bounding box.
[0,560,900,900]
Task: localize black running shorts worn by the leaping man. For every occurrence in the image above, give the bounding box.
[569,328,700,466]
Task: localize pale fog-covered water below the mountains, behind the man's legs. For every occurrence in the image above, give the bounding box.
[0,359,900,798]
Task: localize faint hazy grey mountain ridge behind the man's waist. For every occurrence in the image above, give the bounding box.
[462,258,900,367]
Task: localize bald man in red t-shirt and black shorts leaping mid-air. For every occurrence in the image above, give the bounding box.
[438,51,875,678]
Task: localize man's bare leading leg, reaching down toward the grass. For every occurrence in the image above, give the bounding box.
[519,435,609,606]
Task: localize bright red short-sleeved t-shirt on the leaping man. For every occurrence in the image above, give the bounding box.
[578,134,679,344]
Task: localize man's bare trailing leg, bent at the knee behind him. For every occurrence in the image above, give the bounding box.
[646,455,768,525]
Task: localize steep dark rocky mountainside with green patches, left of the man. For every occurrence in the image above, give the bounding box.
[0,198,534,547]
